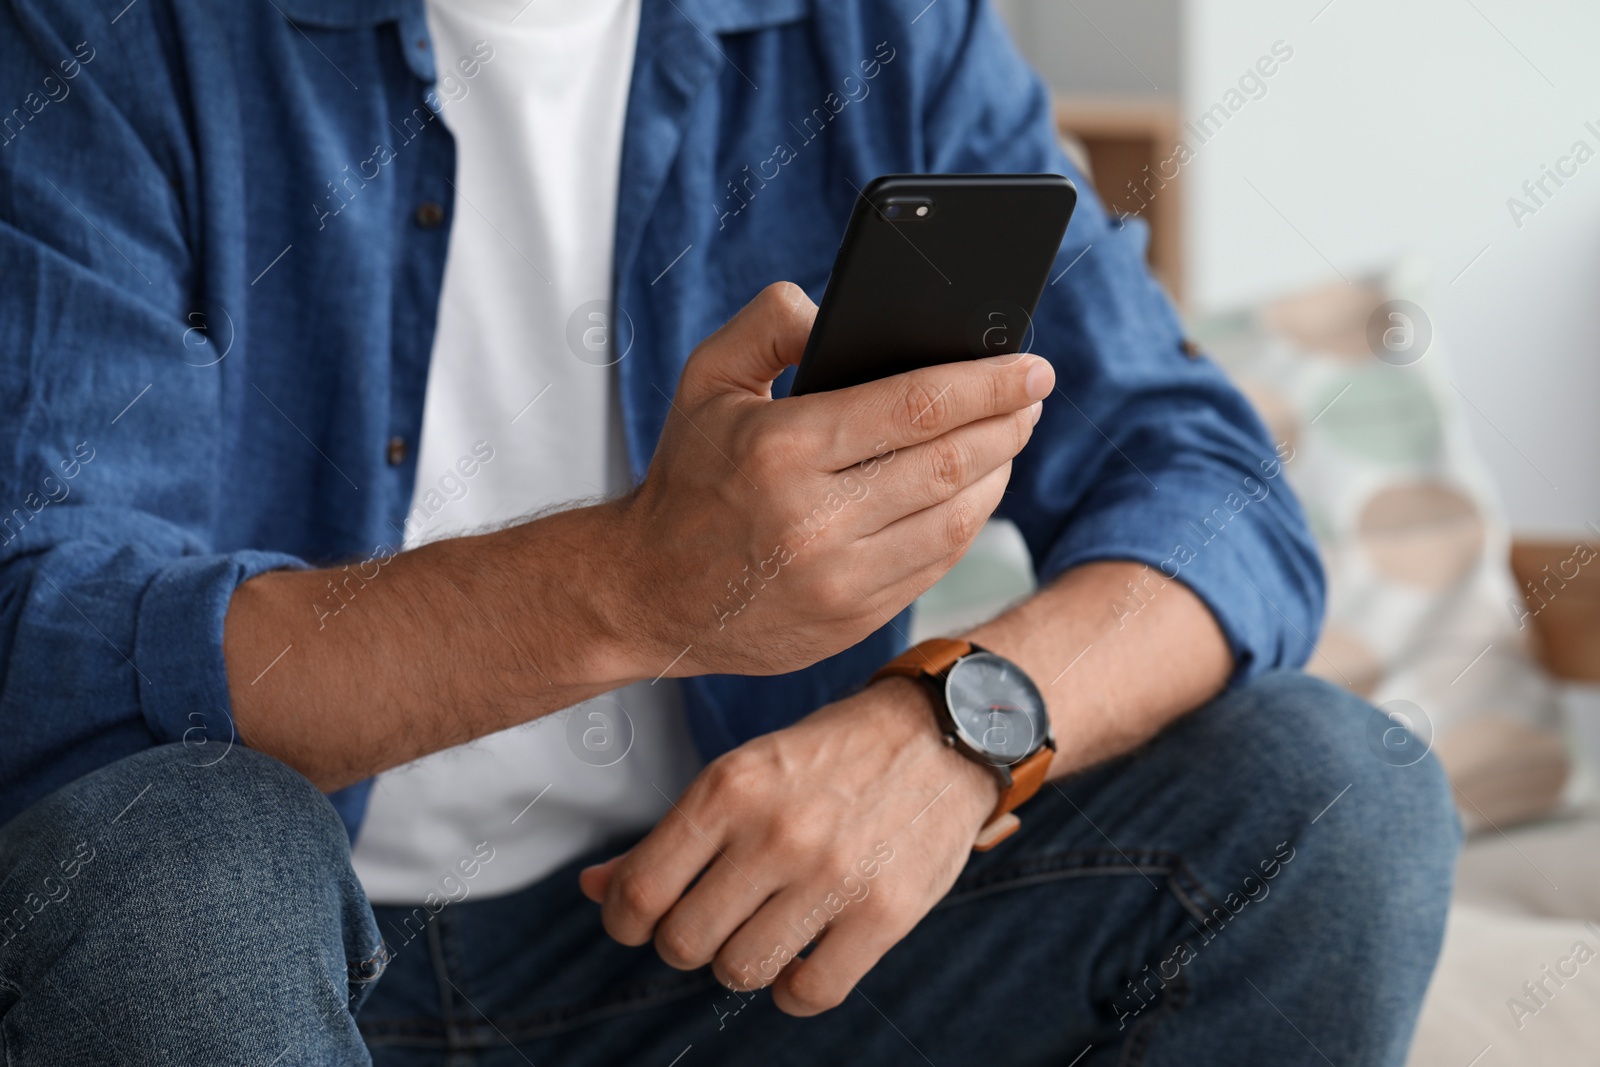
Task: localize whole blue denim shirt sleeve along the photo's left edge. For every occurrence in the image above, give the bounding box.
[0,13,302,821]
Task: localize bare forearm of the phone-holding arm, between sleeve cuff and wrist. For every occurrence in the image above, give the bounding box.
[224,506,643,790]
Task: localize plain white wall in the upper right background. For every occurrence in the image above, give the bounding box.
[1184,0,1600,531]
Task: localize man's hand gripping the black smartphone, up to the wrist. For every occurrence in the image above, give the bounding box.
[606,283,1054,677]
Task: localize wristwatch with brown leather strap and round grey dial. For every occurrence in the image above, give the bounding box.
[869,637,1056,853]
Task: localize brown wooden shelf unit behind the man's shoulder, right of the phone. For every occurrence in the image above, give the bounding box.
[1056,96,1184,307]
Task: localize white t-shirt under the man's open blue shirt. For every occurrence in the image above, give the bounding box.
[355,0,699,904]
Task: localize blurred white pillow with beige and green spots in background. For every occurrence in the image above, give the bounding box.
[1194,262,1570,829]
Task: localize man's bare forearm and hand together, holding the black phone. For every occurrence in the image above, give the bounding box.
[222,285,1054,790]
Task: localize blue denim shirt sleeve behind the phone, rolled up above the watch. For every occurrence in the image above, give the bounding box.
[922,0,1325,683]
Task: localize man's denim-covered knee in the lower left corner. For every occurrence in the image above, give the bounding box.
[0,745,387,1062]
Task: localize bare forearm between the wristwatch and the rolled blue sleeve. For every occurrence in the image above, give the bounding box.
[965,561,1234,777]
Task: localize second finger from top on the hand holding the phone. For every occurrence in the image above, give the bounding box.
[845,402,1042,534]
